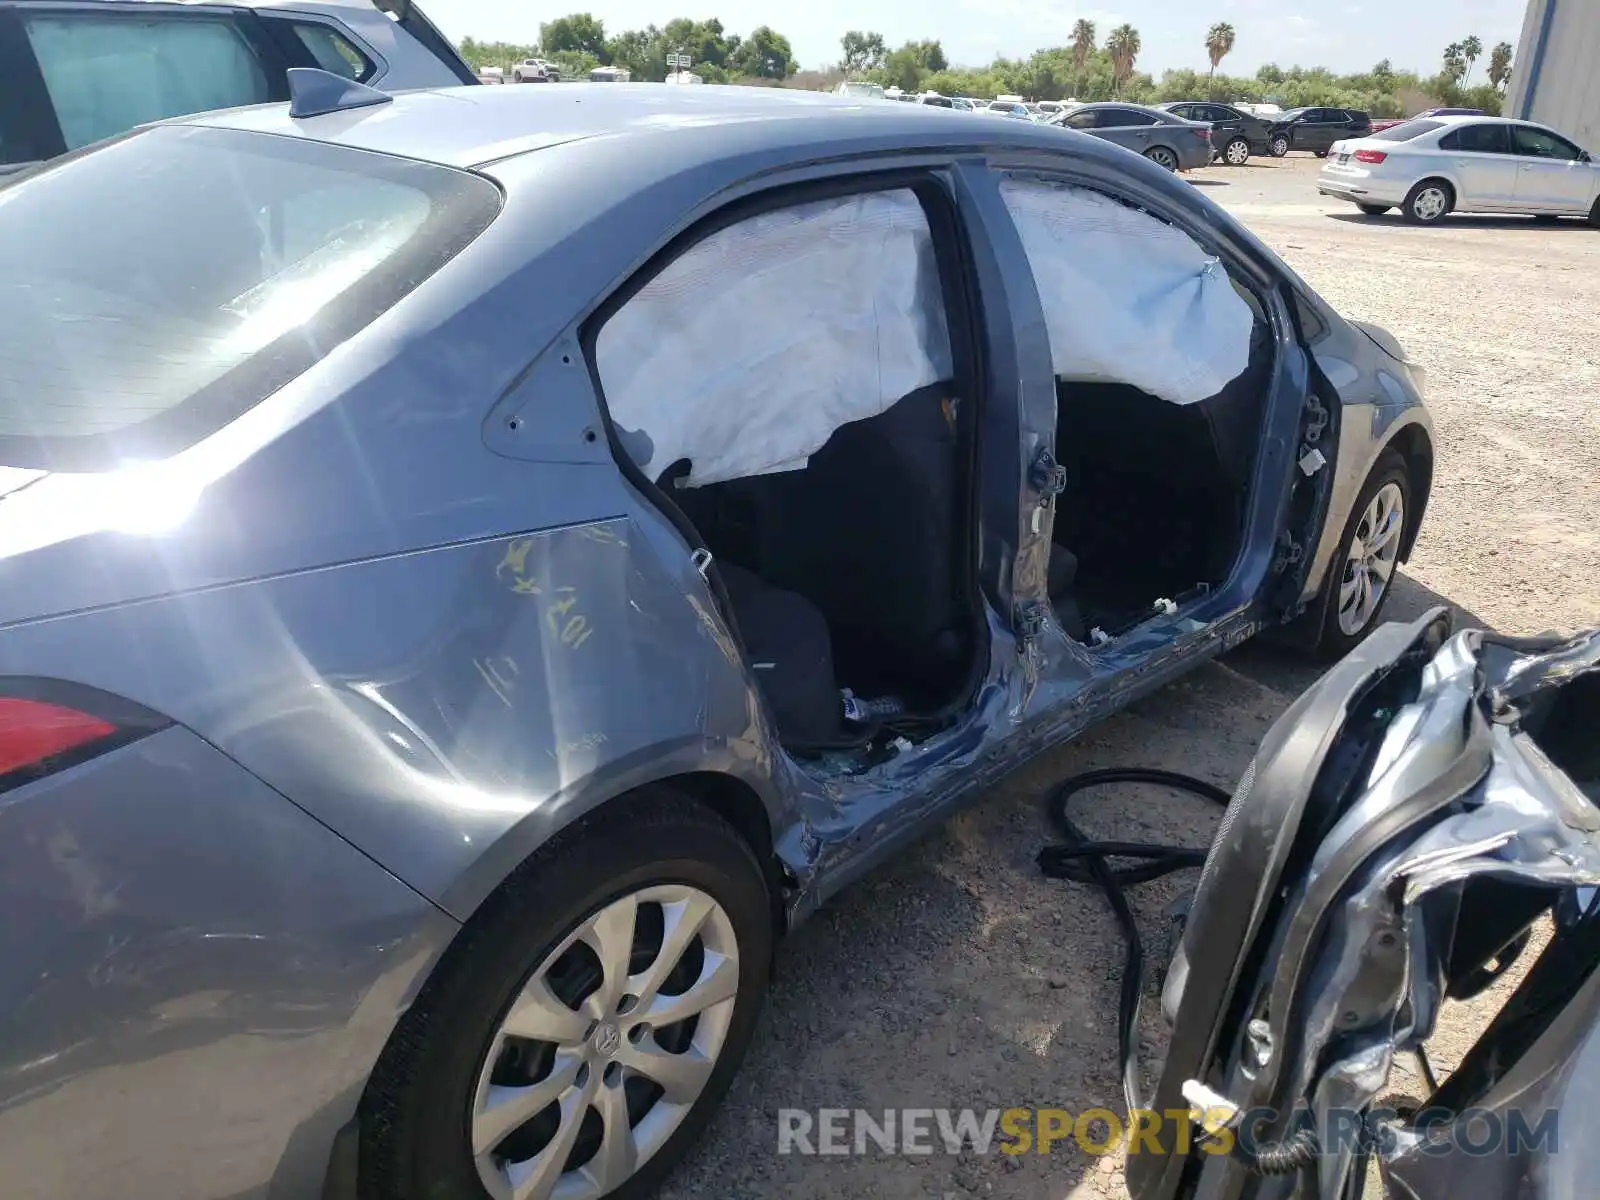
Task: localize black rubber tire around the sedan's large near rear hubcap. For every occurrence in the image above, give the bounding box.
[358,789,773,1200]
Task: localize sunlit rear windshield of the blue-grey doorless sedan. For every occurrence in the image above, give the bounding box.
[0,126,499,470]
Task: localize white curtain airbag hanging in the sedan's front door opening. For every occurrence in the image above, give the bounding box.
[1000,178,1254,405]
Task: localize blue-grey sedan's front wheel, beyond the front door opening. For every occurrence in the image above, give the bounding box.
[1317,450,1411,658]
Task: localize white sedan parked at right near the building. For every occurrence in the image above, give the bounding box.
[1317,117,1600,224]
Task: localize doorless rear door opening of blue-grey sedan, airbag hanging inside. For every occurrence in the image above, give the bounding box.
[594,189,986,755]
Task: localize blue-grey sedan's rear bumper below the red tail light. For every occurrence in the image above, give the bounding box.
[0,728,458,1200]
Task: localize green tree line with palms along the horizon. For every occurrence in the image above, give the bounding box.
[461,13,1512,117]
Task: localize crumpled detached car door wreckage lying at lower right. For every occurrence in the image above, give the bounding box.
[1128,611,1600,1200]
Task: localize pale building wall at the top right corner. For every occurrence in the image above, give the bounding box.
[1506,0,1600,155]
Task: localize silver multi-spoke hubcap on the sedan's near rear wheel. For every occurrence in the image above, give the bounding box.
[469,885,739,1200]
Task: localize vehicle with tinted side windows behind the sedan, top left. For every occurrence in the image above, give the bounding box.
[0,0,478,176]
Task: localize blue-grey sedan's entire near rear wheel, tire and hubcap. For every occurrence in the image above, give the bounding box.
[360,792,773,1200]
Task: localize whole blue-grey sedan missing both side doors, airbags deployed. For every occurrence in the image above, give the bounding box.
[0,70,1434,1200]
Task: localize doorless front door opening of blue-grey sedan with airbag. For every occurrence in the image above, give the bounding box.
[1002,176,1274,642]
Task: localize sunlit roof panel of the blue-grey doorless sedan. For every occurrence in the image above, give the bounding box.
[175,83,1088,168]
